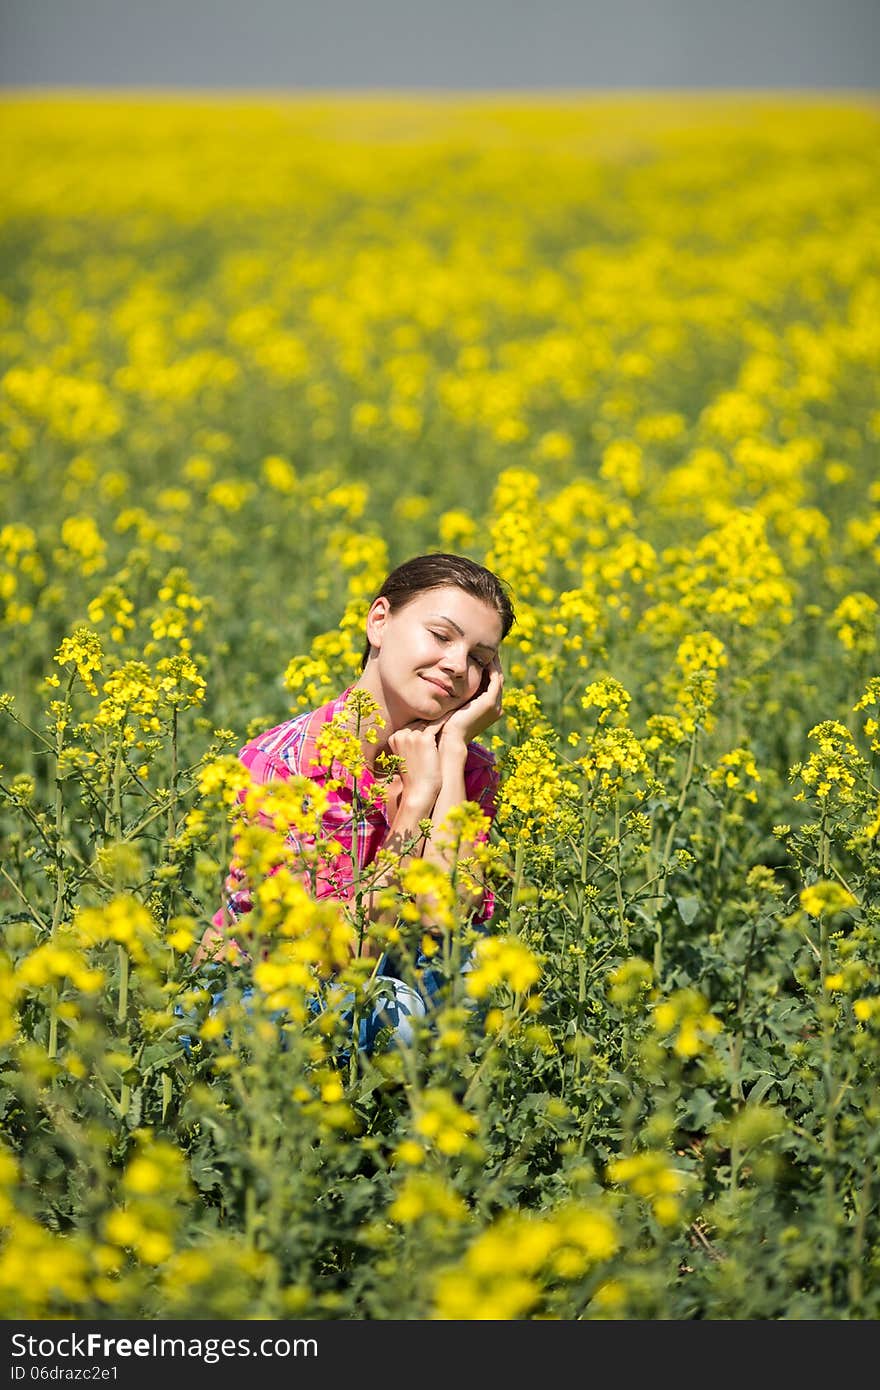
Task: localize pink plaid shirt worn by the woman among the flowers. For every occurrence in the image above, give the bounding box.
[213,687,498,927]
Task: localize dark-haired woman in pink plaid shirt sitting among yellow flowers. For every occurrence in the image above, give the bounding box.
[195,555,514,1049]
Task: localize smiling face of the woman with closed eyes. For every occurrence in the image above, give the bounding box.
[367,585,502,723]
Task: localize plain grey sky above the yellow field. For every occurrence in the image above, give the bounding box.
[0,0,880,90]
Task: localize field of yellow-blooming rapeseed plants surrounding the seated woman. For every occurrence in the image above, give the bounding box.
[0,93,880,1319]
